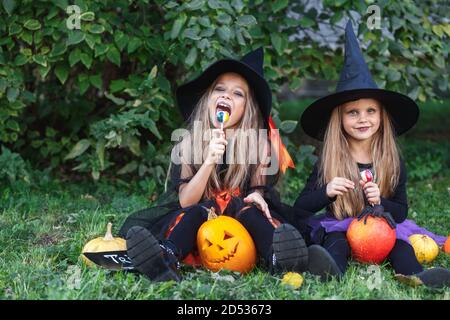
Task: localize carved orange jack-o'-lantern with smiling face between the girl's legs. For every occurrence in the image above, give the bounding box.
[197,208,256,273]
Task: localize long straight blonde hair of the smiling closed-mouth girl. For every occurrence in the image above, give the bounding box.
[319,105,400,220]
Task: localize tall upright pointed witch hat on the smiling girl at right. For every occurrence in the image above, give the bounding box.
[300,21,419,140]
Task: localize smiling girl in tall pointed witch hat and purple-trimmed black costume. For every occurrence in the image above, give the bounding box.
[286,22,450,287]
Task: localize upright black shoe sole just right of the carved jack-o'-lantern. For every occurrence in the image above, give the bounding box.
[269,224,308,273]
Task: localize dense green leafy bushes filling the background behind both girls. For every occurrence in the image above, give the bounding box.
[0,0,450,183]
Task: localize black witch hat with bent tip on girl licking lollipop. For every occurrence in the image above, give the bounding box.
[176,48,272,120]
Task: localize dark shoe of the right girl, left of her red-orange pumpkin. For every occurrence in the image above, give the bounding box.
[308,244,343,281]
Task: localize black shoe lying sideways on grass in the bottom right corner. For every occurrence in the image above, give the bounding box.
[395,267,450,288]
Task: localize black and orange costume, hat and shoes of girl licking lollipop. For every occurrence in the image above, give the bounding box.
[120,48,327,281]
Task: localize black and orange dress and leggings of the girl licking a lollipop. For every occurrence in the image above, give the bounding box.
[120,155,306,265]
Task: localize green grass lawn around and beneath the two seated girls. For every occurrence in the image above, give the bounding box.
[0,101,450,300]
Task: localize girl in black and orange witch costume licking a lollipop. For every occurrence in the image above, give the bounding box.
[121,49,330,281]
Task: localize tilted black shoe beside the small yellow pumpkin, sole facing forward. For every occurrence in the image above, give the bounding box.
[127,227,181,282]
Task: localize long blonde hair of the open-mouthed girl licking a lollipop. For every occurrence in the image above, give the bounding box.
[181,79,264,198]
